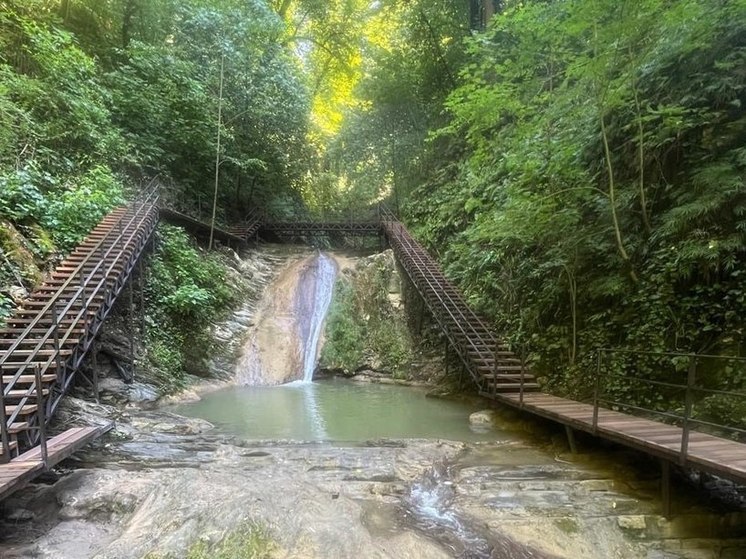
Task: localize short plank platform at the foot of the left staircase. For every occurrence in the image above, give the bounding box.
[0,424,113,500]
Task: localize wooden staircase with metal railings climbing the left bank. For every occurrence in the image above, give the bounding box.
[0,189,158,463]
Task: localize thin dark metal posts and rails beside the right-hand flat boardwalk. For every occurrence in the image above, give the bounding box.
[593,348,746,464]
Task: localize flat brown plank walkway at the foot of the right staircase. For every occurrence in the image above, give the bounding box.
[486,392,746,484]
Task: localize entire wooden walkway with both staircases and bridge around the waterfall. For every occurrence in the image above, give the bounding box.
[0,197,746,516]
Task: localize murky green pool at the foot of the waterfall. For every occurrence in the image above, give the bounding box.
[173,379,507,443]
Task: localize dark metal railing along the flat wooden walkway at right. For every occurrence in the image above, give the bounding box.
[593,348,746,463]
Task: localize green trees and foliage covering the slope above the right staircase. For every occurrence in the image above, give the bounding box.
[324,0,746,428]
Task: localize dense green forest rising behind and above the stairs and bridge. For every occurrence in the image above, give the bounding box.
[0,0,746,412]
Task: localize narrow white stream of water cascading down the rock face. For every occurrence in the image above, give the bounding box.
[299,253,337,382]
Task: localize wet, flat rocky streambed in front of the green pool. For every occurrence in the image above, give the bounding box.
[0,401,746,559]
